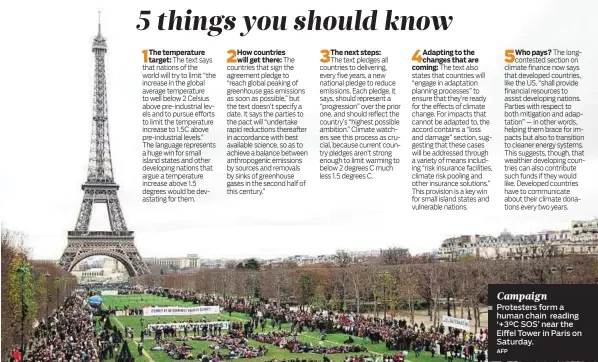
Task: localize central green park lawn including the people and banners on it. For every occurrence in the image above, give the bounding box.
[100,294,444,362]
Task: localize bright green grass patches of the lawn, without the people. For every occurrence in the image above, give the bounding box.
[102,295,444,362]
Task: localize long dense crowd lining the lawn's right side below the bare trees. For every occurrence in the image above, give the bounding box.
[146,288,488,361]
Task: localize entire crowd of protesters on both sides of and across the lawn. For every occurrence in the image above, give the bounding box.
[7,288,488,362]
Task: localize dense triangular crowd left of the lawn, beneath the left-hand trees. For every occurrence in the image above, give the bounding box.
[11,295,100,362]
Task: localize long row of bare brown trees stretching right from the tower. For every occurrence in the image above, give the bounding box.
[134,252,598,328]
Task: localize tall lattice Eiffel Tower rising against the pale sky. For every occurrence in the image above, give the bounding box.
[58,16,149,276]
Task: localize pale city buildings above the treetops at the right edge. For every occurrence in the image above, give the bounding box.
[437,219,598,261]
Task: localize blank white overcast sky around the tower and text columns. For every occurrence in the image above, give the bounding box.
[0,1,598,259]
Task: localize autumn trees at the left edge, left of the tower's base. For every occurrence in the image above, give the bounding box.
[0,227,77,356]
